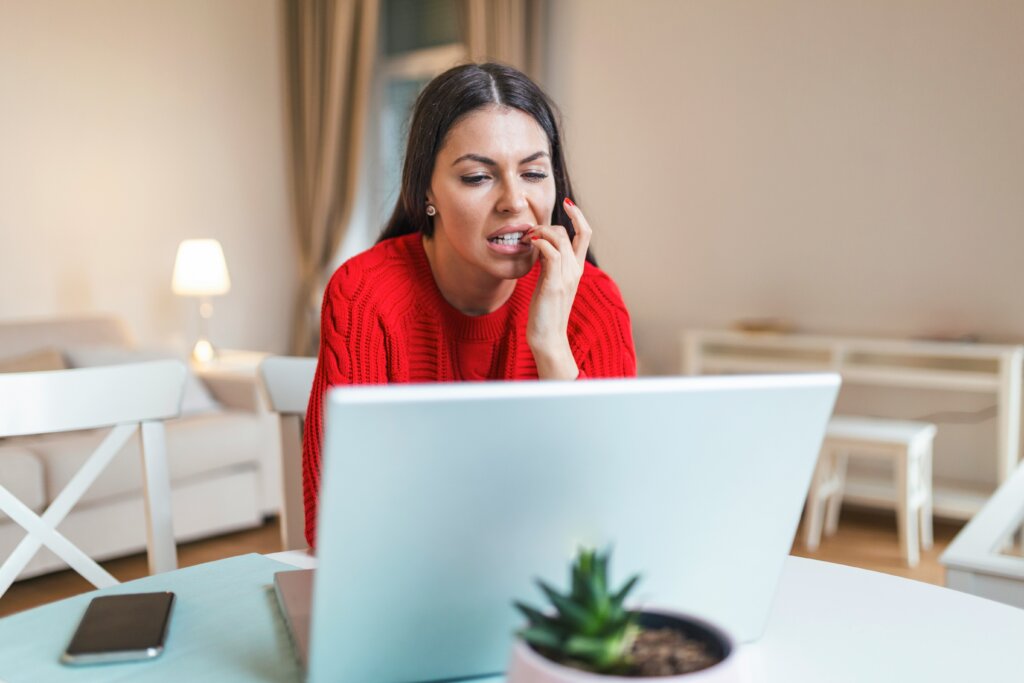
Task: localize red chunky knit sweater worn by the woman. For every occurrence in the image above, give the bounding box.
[302,233,636,546]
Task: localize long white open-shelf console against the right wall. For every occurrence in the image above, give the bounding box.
[682,330,1024,519]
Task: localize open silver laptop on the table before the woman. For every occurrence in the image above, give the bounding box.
[276,374,840,683]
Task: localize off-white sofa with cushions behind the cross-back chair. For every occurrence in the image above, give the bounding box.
[0,316,281,579]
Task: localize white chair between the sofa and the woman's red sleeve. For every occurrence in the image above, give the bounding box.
[259,355,316,550]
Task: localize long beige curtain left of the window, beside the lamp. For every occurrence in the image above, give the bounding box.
[284,0,379,355]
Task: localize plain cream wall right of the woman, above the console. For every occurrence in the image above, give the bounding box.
[547,0,1024,376]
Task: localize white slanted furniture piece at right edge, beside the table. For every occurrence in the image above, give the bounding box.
[940,458,1024,608]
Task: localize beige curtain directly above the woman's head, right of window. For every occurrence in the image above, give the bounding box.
[463,0,546,80]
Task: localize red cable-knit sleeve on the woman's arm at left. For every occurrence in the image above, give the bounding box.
[302,266,387,548]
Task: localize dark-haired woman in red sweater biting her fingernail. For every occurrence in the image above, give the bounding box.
[303,63,636,546]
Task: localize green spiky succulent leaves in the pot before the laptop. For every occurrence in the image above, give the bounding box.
[515,549,640,673]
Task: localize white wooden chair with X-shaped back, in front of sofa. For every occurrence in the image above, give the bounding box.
[0,360,185,596]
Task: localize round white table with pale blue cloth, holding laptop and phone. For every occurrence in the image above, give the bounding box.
[6,551,1024,683]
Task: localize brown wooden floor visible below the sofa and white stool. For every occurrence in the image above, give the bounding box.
[0,510,962,616]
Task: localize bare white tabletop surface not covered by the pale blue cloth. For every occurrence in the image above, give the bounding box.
[268,551,1024,683]
